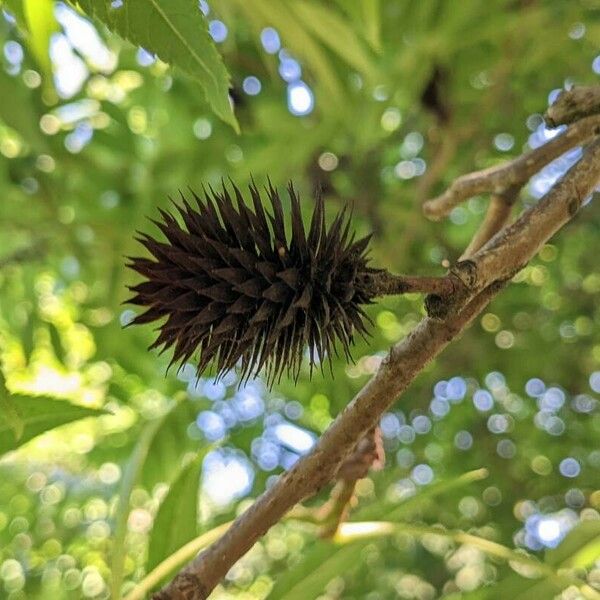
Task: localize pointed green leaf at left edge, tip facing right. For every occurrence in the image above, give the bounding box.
[0,394,106,455]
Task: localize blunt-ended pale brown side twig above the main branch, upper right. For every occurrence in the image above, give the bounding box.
[423,115,600,220]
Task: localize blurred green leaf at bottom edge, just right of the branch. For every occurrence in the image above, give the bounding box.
[268,540,369,600]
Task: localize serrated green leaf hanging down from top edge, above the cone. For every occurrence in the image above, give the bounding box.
[70,0,239,132]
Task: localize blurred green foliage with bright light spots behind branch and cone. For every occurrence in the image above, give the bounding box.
[0,0,600,600]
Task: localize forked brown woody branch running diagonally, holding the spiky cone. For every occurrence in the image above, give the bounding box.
[145,87,600,600]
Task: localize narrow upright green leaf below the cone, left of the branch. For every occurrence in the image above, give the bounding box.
[146,446,209,571]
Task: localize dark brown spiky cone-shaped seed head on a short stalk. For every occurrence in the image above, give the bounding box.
[128,184,454,385]
